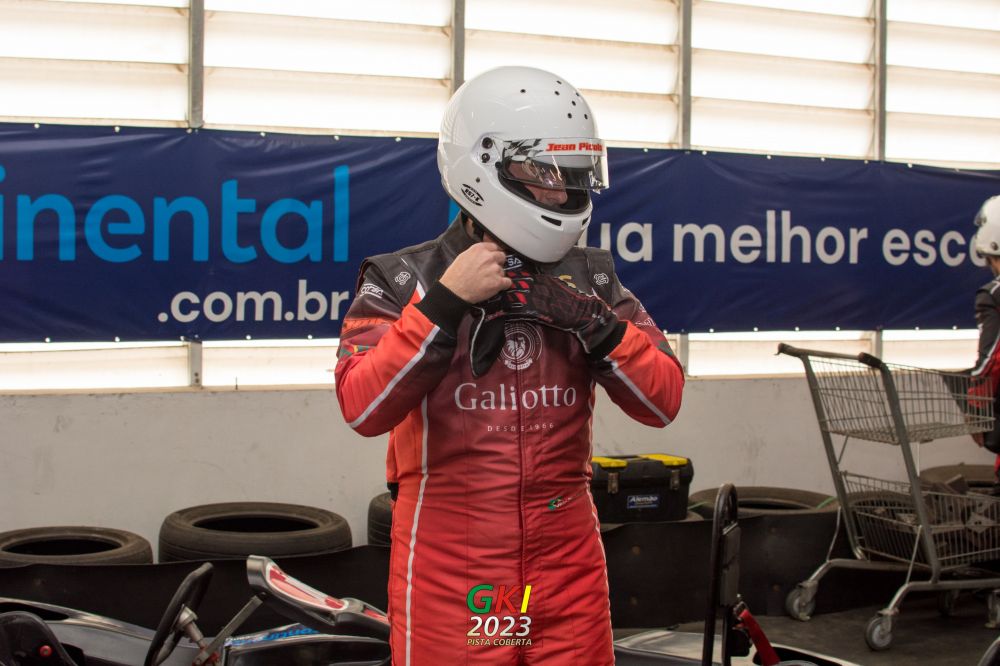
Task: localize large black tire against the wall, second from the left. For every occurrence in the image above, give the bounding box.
[160,502,351,562]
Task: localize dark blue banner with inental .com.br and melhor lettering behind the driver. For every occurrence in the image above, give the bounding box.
[0,125,1000,342]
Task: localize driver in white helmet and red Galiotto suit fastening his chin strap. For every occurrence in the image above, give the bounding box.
[336,67,684,666]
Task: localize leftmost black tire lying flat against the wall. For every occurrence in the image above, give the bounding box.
[0,526,153,567]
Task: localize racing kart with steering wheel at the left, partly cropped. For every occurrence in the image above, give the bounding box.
[0,556,391,666]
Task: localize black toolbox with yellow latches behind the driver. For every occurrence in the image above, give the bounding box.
[590,453,694,523]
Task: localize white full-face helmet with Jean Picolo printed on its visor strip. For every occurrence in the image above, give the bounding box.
[438,67,608,263]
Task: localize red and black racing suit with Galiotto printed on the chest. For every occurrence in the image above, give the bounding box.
[336,220,684,666]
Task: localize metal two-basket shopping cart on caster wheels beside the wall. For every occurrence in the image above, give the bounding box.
[778,344,1000,650]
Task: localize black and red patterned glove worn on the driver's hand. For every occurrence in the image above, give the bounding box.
[502,271,625,358]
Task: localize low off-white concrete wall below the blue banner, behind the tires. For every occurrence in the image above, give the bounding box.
[0,377,993,551]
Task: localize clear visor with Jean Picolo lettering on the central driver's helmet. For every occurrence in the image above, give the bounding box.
[500,139,608,192]
